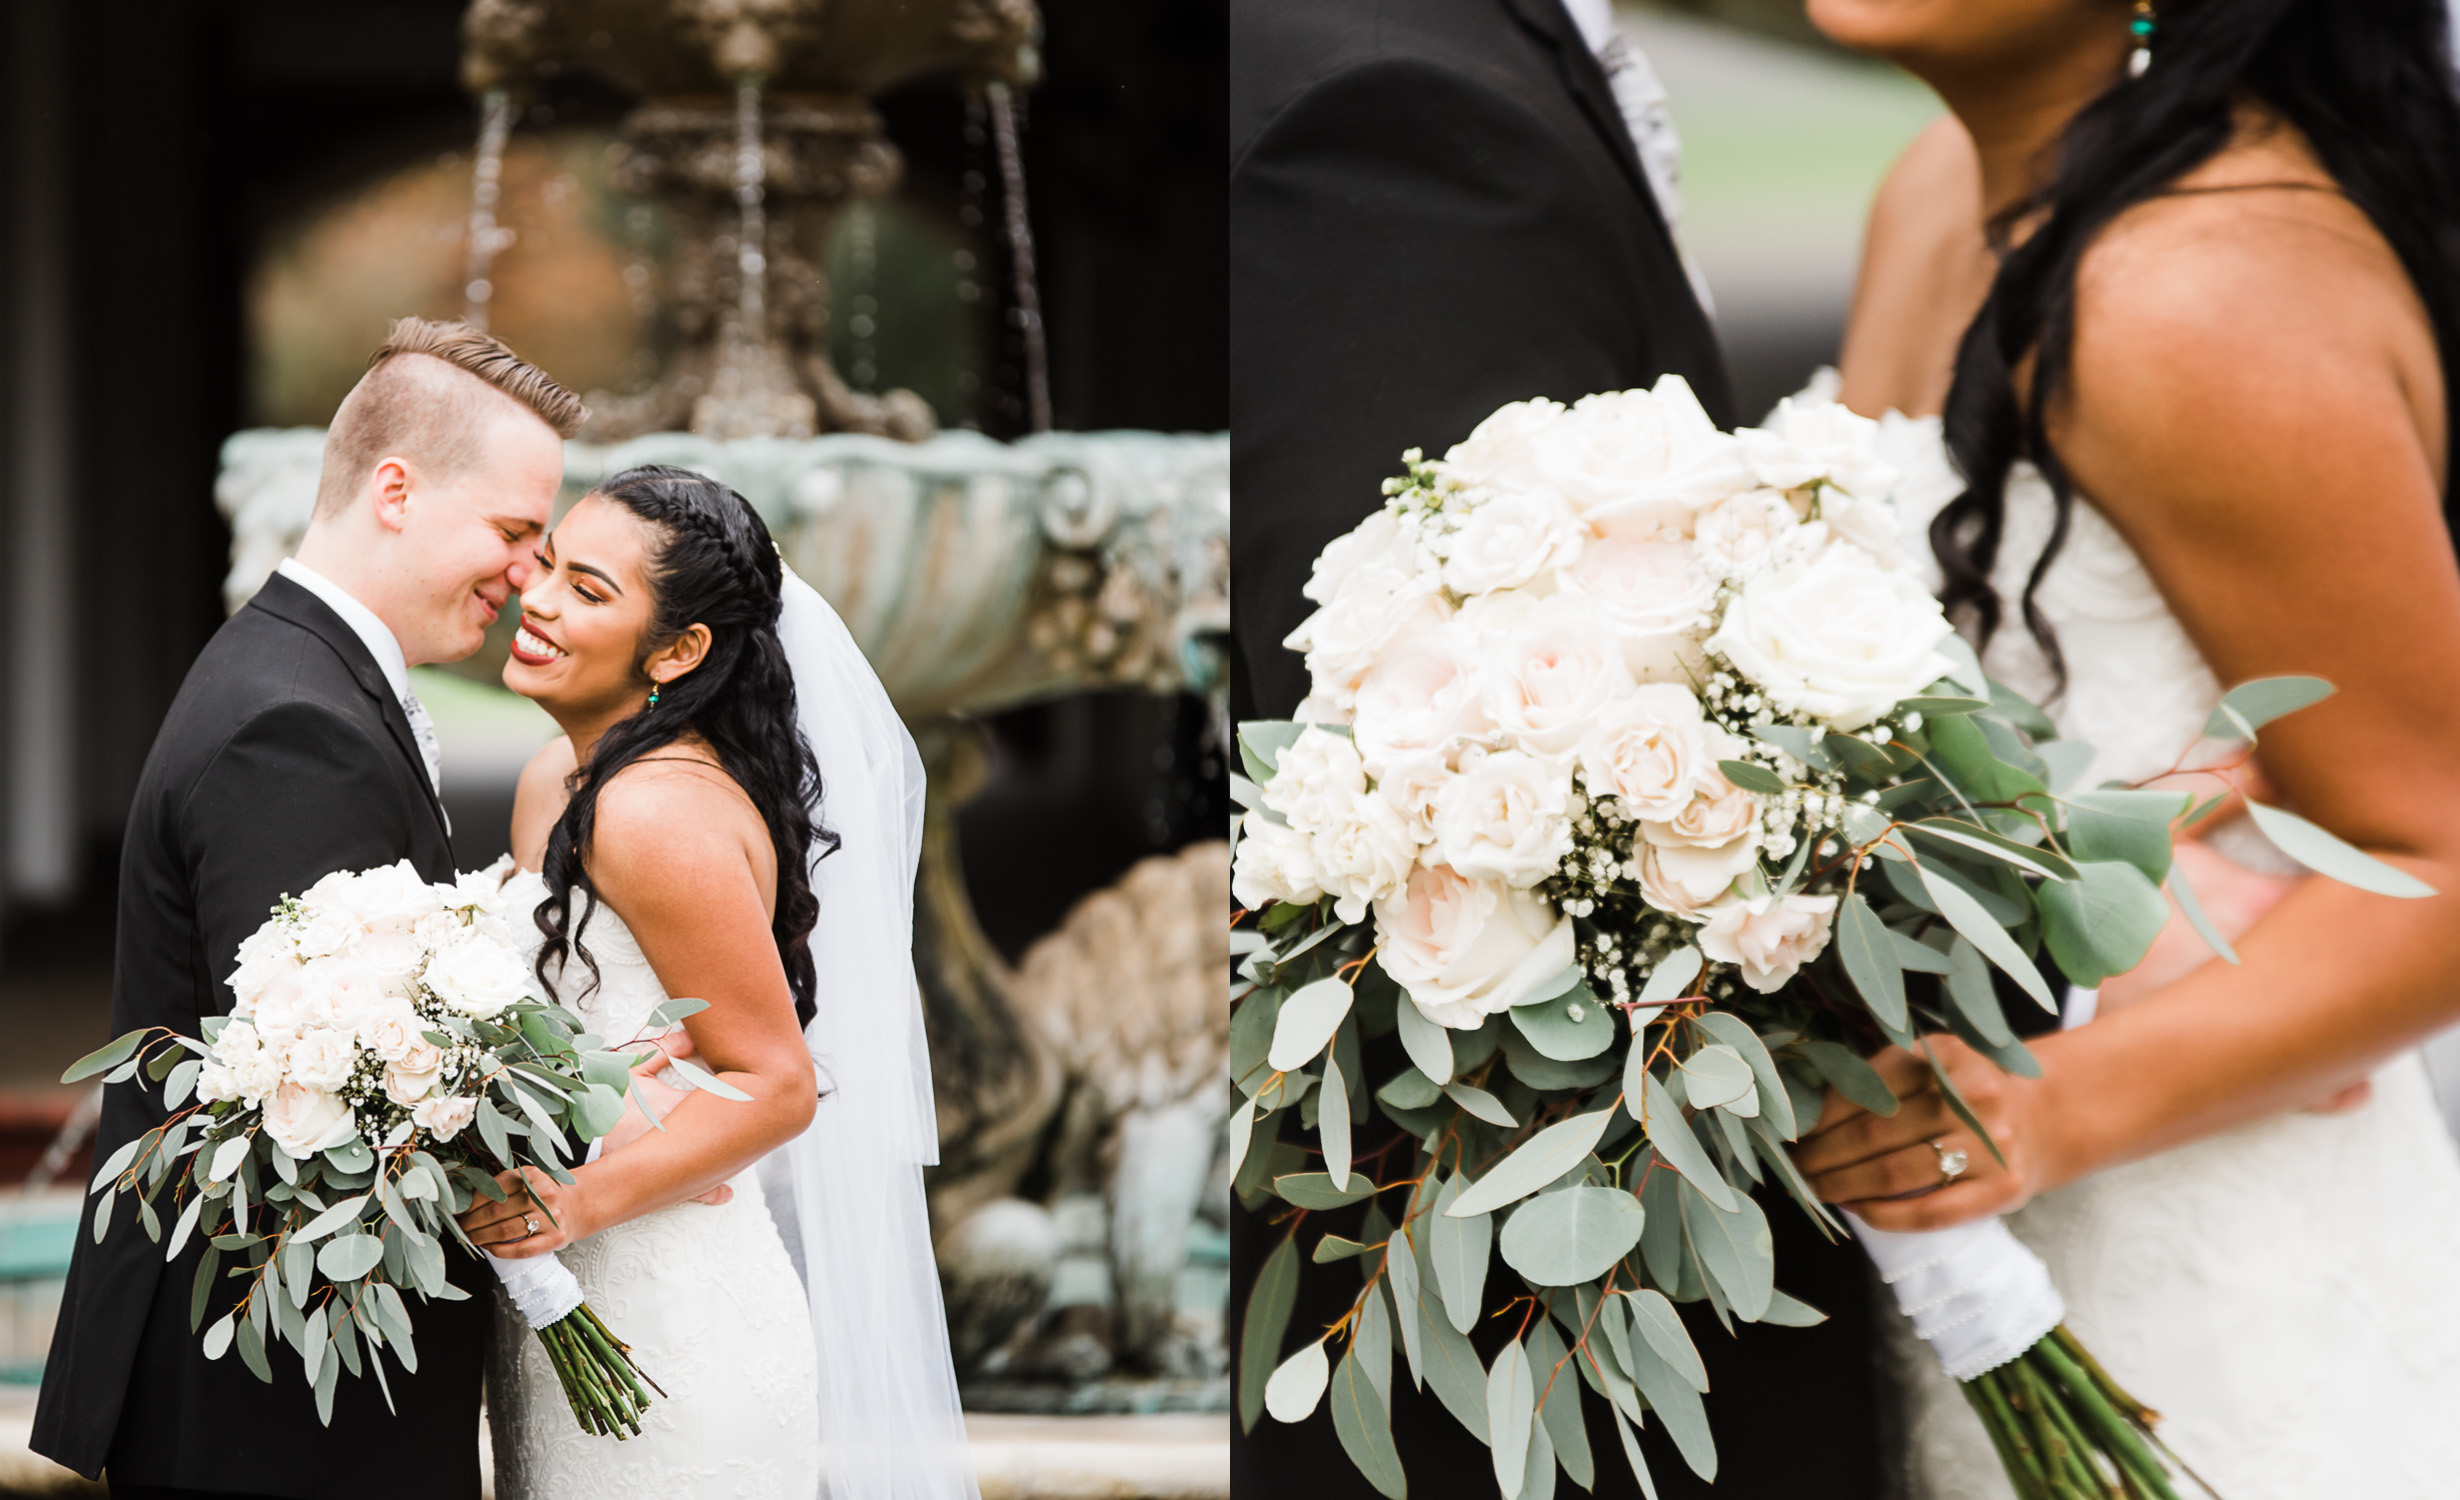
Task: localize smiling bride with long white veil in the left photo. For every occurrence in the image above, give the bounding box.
[462,465,974,1500]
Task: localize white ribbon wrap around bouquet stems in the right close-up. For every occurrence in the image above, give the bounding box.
[1845,1212,2066,1380]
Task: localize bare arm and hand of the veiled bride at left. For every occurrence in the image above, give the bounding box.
[462,765,817,1257]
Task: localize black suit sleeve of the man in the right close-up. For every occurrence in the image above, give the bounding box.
[1230,59,1690,716]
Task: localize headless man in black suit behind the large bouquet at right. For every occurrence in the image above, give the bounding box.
[1230,0,1877,1500]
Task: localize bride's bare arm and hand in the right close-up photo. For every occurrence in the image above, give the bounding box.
[1798,180,2460,1230]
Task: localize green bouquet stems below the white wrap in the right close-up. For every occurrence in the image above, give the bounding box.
[1963,1323,2209,1500]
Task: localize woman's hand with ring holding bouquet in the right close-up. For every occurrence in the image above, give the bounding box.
[1793,1035,2061,1232]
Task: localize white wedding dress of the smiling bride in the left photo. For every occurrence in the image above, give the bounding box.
[487,870,819,1500]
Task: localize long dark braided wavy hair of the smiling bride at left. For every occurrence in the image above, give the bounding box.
[534,465,836,1025]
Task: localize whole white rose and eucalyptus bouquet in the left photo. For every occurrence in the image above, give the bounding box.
[64,861,728,1436]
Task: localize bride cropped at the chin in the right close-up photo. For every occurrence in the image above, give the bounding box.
[1798,0,2460,1500]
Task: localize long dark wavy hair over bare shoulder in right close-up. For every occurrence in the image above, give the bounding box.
[1931,0,2460,681]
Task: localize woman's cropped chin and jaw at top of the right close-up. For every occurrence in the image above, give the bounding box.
[1808,0,2133,84]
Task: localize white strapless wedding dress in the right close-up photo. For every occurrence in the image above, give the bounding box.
[1882,403,2460,1500]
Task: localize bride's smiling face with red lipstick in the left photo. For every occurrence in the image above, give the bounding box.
[504,494,706,718]
